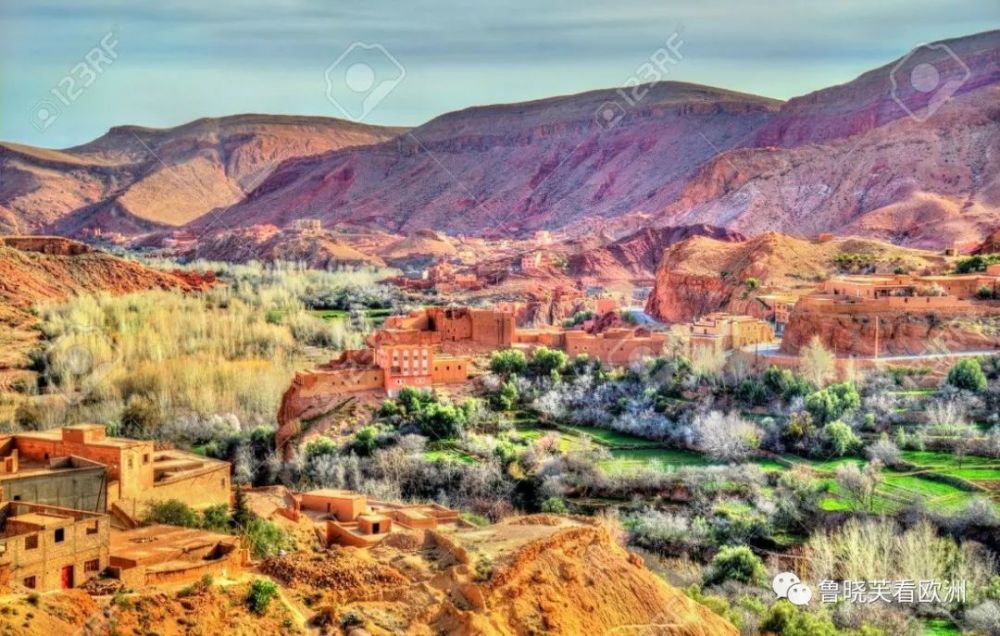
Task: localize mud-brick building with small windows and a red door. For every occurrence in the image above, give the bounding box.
[0,501,111,591]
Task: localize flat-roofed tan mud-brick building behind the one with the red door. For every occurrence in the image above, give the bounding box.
[0,424,230,518]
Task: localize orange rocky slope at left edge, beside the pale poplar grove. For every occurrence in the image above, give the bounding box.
[0,237,207,371]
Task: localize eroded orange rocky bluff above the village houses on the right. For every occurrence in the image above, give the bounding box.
[646,232,945,322]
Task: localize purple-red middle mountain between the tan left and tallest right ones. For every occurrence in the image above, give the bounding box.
[188,82,780,236]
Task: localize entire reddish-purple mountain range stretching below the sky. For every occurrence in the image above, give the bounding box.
[0,31,1000,247]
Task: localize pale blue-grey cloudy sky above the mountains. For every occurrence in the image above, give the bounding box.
[0,0,1000,148]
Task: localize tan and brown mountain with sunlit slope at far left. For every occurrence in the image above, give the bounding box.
[0,115,400,235]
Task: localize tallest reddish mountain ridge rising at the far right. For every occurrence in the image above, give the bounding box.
[656,31,1000,247]
